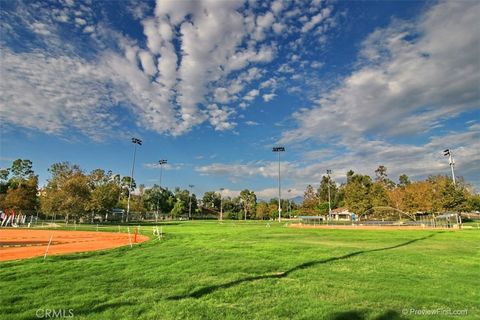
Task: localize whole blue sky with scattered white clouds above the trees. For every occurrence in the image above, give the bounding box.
[0,0,480,198]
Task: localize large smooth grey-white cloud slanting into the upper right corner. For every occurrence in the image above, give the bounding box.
[282,2,480,142]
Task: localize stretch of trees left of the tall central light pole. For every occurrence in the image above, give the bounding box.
[0,159,287,221]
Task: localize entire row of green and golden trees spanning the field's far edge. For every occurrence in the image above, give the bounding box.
[0,159,480,221]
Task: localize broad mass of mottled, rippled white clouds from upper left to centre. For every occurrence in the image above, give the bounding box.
[1,0,342,137]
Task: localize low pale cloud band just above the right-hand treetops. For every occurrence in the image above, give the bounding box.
[195,124,480,190]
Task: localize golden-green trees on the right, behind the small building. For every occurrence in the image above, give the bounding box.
[302,165,480,215]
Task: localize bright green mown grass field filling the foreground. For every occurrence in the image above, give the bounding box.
[0,222,480,319]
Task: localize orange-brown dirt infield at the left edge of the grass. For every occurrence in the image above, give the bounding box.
[0,229,149,261]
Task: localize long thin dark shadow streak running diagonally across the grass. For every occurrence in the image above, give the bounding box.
[167,233,435,300]
